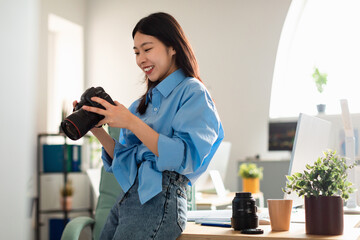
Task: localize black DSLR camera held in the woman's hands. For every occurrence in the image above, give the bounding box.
[61,87,115,140]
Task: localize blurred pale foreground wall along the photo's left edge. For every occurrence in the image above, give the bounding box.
[0,0,39,239]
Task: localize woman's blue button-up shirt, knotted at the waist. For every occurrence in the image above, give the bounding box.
[102,69,224,204]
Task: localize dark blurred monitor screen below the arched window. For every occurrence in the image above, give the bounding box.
[268,121,297,151]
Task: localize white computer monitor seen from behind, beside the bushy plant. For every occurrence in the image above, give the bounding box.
[284,113,331,207]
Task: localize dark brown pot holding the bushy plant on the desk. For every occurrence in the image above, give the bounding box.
[305,196,344,235]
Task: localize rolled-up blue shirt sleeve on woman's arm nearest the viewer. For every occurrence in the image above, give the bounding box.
[156,89,222,175]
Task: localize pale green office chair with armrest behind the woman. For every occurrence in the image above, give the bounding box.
[61,127,122,240]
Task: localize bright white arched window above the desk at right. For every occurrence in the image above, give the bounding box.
[270,0,360,118]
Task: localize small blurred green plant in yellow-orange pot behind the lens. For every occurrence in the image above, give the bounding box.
[238,163,263,193]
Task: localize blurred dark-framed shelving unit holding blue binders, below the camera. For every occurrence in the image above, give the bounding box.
[35,133,93,240]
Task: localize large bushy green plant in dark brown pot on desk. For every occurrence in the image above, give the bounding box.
[283,150,355,235]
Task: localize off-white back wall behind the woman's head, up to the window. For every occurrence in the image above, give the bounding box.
[87,0,291,191]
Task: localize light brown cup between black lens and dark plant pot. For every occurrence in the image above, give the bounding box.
[267,199,293,231]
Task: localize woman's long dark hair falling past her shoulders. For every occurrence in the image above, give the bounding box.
[132,12,201,114]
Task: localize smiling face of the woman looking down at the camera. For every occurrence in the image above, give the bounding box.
[134,32,177,82]
